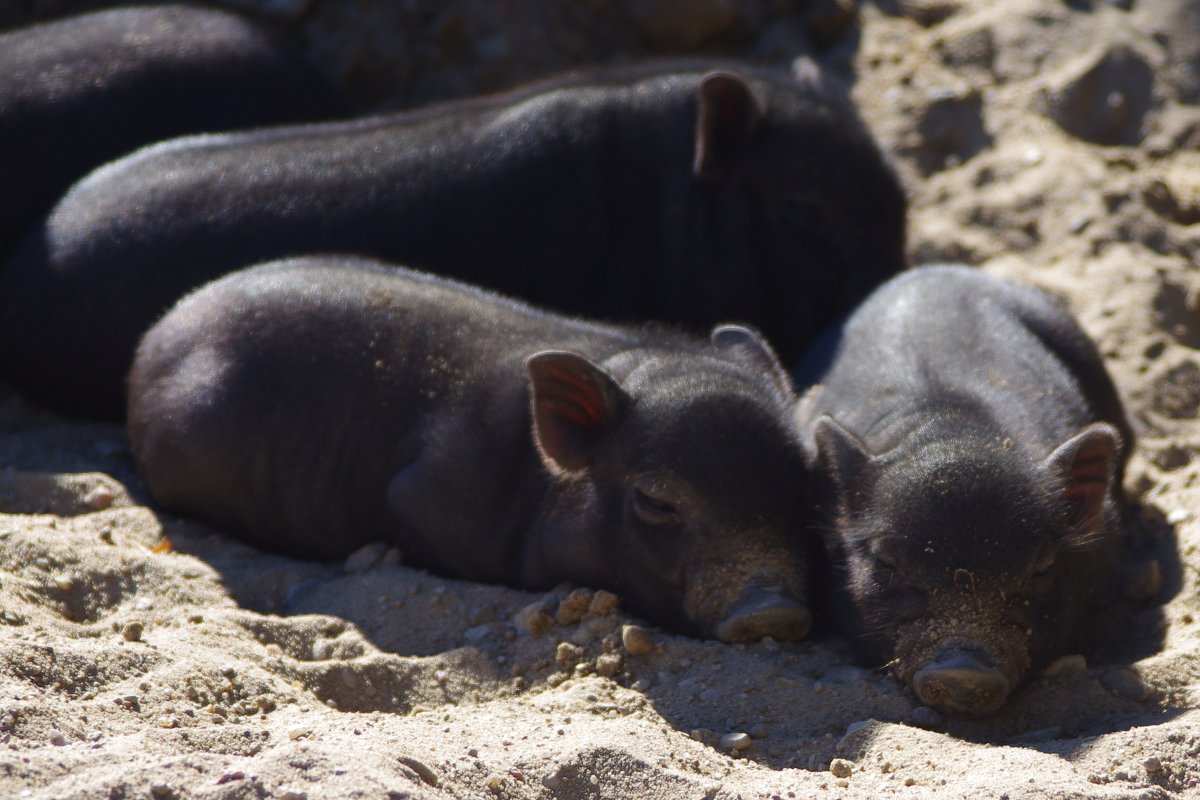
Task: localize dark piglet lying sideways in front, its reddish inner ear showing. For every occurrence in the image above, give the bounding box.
[128,257,810,642]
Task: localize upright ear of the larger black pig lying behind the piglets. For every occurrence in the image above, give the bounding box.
[691,72,764,182]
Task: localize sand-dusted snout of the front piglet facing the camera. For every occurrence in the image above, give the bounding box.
[892,615,1030,717]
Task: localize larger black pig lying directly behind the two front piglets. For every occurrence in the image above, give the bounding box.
[0,66,905,416]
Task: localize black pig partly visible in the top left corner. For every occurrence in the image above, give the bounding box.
[0,6,336,251]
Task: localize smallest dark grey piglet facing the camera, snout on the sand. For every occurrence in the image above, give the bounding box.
[798,266,1132,715]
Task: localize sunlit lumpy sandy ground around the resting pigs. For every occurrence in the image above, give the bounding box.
[0,0,1200,800]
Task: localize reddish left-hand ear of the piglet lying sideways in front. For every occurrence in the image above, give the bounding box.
[526,350,625,470]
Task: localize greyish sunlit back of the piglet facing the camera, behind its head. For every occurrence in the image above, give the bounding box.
[809,266,1128,458]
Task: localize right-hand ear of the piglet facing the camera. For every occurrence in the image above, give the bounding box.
[1045,422,1121,535]
